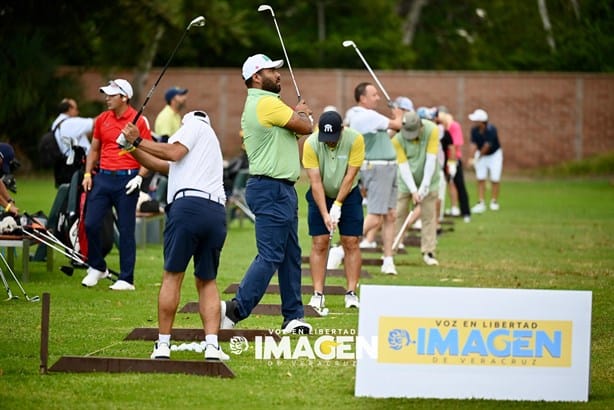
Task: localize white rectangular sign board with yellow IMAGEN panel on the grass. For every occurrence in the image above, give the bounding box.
[355,285,592,401]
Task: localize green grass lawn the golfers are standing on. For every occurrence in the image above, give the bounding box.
[0,177,614,409]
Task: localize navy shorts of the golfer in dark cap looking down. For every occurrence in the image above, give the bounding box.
[305,187,364,236]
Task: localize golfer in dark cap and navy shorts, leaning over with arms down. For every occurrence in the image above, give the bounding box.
[303,111,365,310]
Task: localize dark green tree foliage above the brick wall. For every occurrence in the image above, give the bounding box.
[0,0,614,167]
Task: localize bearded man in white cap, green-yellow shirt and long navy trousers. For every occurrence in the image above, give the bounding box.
[220,54,312,334]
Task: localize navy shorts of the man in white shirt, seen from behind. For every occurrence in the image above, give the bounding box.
[164,197,226,280]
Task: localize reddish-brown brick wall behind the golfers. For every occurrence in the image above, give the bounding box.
[82,68,614,171]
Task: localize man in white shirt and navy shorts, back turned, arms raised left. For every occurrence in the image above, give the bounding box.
[123,111,229,360]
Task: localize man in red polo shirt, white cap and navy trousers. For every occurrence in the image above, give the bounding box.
[81,79,151,290]
